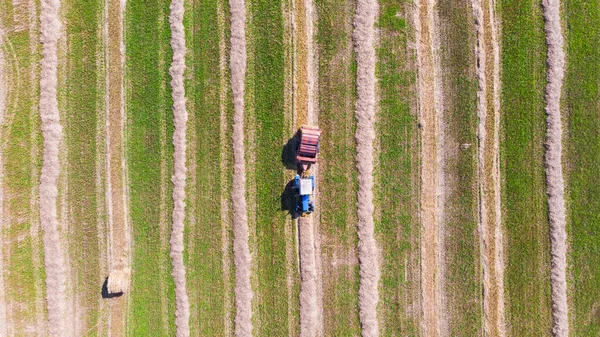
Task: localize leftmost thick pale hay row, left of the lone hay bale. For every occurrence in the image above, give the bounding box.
[39,0,73,336]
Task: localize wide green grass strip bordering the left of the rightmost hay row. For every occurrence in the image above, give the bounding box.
[501,0,552,336]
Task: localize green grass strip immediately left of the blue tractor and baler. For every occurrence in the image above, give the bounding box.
[246,0,298,336]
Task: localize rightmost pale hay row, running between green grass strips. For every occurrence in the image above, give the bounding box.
[543,0,569,336]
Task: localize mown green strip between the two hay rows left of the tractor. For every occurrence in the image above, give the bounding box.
[184,1,235,336]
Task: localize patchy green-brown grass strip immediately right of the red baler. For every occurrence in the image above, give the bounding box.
[315,0,360,336]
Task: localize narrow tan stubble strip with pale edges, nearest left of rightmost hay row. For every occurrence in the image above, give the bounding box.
[472,0,505,336]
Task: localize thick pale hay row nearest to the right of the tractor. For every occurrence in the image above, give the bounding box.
[354,0,380,336]
